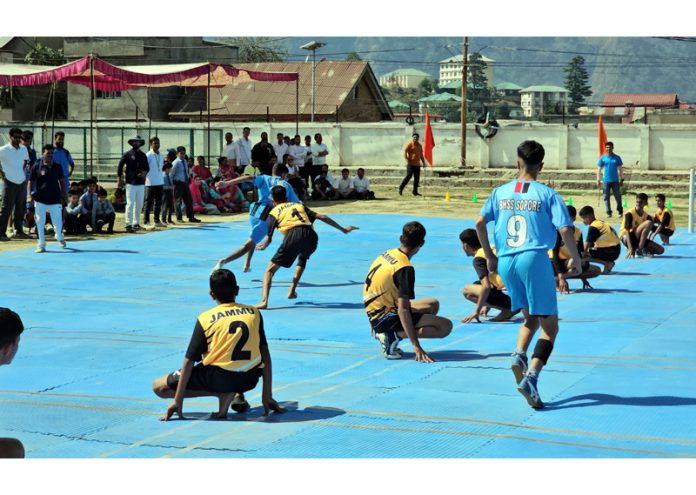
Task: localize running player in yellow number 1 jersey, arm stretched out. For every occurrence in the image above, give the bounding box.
[256,186,358,309]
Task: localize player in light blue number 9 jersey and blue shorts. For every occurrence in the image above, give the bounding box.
[476,141,581,408]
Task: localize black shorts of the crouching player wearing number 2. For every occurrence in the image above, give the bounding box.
[167,363,263,394]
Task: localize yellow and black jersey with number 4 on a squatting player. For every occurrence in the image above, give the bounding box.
[363,248,416,322]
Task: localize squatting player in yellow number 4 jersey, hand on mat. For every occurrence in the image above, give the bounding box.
[363,222,452,363]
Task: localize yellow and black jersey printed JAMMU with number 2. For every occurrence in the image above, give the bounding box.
[186,303,268,371]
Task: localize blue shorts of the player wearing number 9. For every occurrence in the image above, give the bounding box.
[498,249,558,316]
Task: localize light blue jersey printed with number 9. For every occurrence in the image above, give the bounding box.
[480,180,573,257]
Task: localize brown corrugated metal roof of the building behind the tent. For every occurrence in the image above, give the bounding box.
[172,60,390,116]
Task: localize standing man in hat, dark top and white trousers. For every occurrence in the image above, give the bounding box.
[116,136,150,233]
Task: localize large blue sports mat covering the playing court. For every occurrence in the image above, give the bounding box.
[0,215,696,458]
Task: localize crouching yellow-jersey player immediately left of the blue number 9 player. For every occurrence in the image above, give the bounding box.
[459,229,519,323]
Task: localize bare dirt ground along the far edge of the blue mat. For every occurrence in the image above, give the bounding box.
[0,188,688,252]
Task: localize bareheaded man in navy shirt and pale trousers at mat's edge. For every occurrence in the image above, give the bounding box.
[27,144,66,253]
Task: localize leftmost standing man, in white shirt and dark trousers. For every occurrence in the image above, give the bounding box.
[0,127,29,241]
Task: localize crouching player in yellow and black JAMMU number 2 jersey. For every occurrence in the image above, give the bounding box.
[152,269,284,421]
